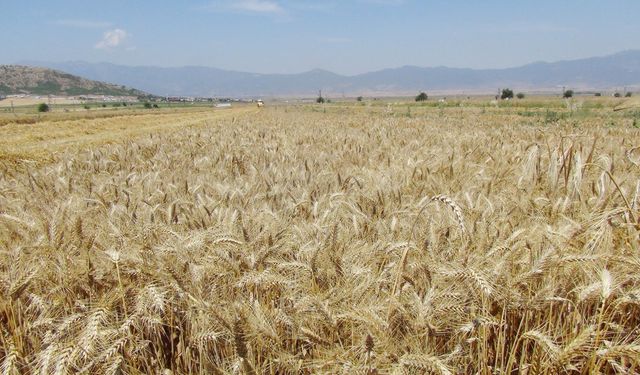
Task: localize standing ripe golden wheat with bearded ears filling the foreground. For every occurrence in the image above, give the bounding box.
[0,101,640,374]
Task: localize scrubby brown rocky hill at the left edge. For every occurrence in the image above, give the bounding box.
[0,65,146,96]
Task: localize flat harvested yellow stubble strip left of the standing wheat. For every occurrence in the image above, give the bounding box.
[0,107,257,162]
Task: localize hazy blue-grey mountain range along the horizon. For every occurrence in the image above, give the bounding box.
[22,50,640,97]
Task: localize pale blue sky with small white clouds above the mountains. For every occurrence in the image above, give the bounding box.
[0,0,640,74]
